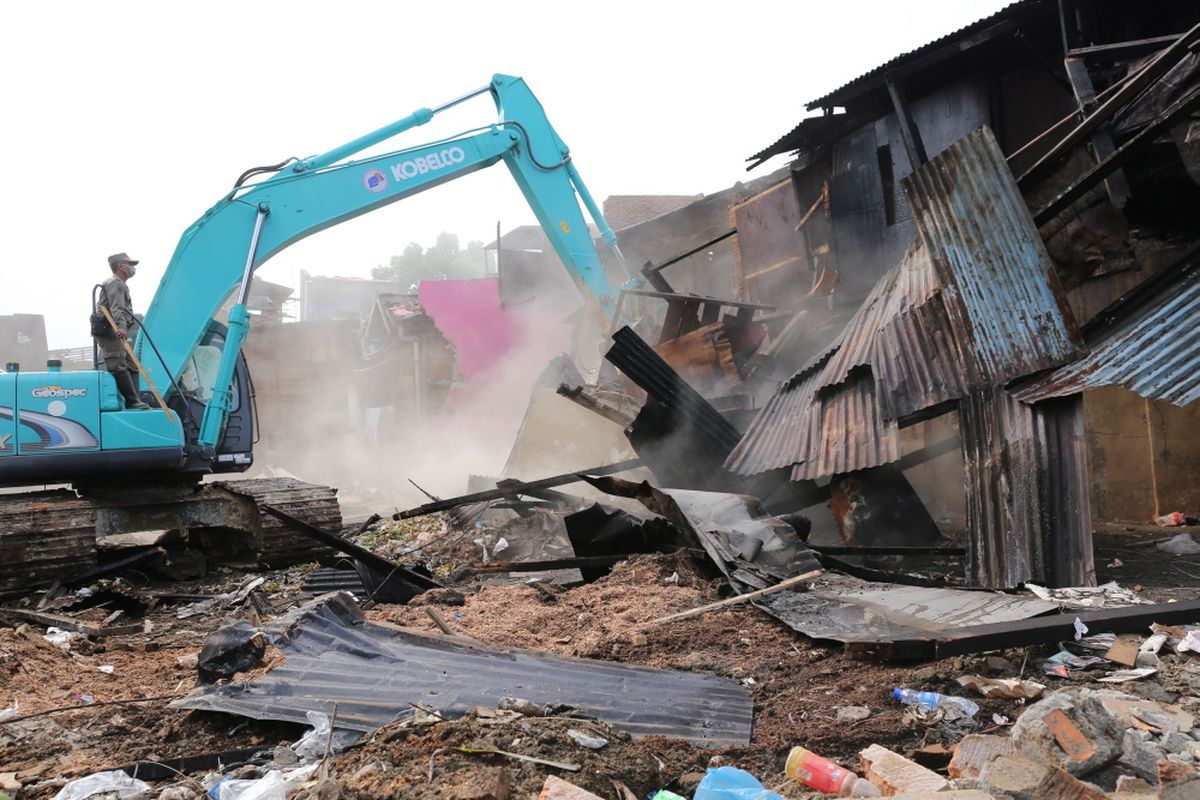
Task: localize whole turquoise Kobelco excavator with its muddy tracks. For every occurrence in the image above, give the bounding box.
[0,74,624,594]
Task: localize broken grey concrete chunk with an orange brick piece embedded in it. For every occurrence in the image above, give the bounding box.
[1013,688,1123,776]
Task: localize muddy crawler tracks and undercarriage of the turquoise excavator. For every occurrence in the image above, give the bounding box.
[0,477,342,595]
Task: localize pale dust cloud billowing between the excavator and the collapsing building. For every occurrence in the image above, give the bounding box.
[250,296,578,518]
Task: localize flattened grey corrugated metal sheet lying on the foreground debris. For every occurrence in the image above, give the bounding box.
[172,595,752,746]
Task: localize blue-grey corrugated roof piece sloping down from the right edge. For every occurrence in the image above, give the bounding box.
[1015,273,1200,407]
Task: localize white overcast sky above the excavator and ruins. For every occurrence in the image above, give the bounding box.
[0,0,1006,348]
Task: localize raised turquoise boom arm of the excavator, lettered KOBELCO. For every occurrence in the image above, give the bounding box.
[138,76,619,445]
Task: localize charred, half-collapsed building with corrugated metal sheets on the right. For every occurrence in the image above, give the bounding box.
[585,0,1200,587]
